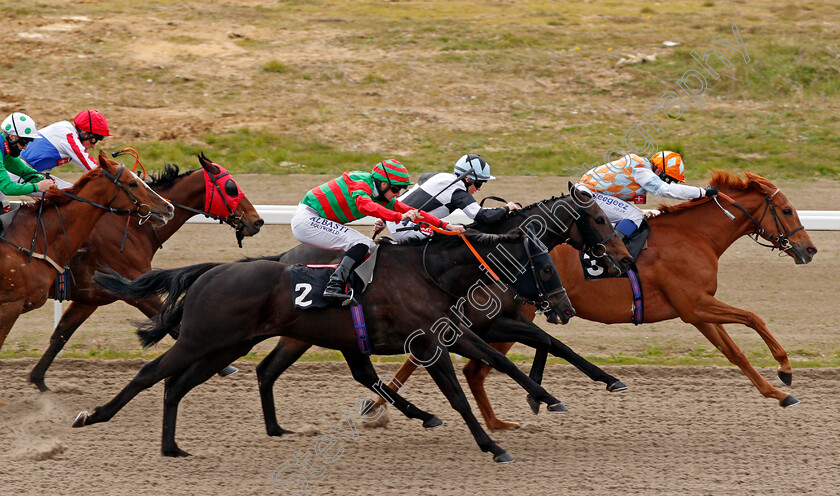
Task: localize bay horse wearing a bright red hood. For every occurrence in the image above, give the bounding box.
[29,153,264,391]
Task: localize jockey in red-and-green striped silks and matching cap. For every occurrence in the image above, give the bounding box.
[291,160,464,301]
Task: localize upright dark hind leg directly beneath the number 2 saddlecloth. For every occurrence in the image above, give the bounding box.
[257,337,312,436]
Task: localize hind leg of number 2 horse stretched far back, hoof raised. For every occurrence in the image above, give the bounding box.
[73,341,200,427]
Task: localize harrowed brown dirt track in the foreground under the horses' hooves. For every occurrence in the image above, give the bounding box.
[0,359,840,496]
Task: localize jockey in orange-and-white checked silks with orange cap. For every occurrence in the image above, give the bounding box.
[580,151,718,238]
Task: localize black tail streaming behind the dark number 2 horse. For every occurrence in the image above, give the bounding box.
[93,262,222,348]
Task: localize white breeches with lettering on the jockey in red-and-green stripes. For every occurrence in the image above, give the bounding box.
[292,203,376,251]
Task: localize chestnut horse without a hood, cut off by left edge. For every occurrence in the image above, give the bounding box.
[0,152,174,366]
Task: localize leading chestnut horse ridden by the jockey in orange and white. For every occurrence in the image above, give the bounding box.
[464,171,817,423]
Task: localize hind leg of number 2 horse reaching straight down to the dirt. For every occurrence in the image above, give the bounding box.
[160,341,254,457]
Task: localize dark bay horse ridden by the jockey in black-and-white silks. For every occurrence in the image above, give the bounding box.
[257,188,631,435]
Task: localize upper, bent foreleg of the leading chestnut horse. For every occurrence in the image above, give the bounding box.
[681,296,793,386]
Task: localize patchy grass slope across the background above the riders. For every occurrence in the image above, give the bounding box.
[4,0,840,179]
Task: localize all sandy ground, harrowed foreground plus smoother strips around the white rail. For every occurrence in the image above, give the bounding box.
[0,176,840,495]
